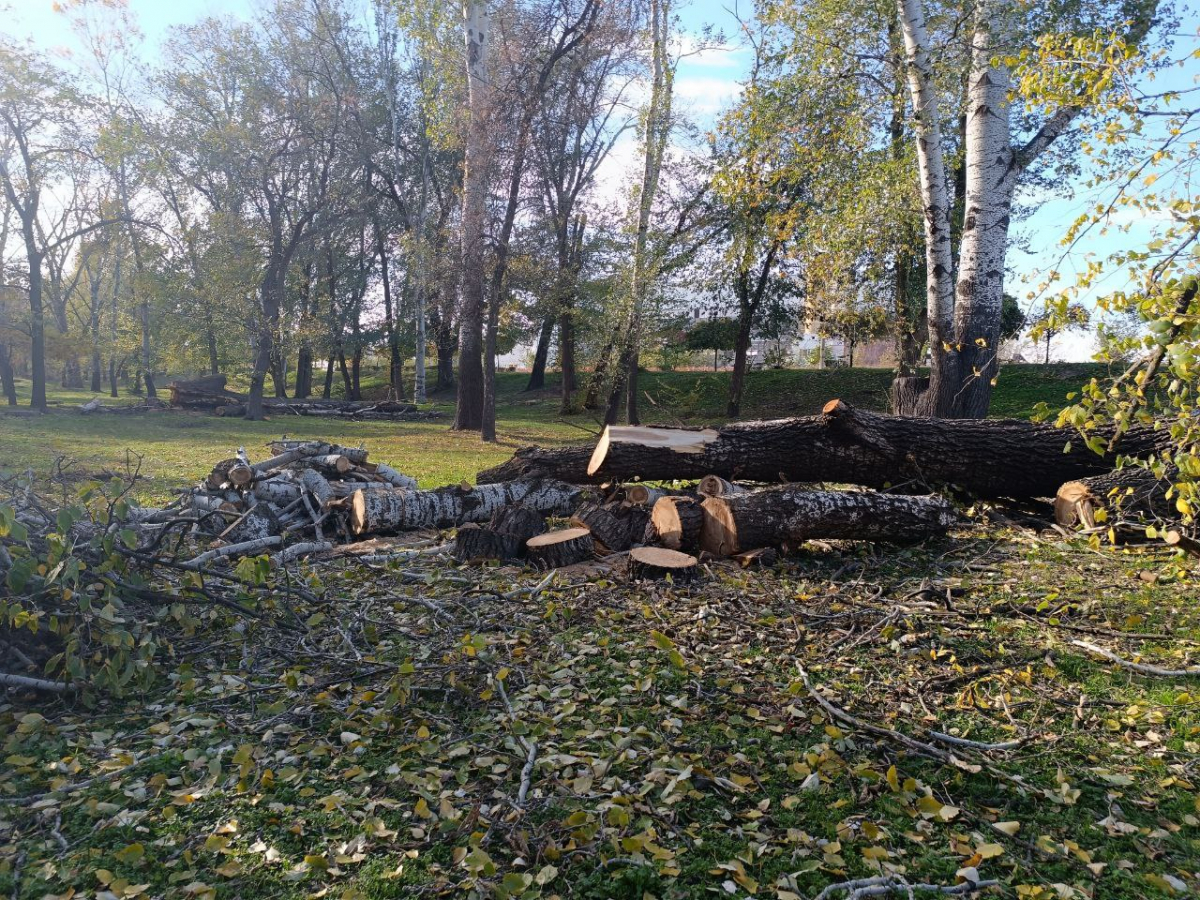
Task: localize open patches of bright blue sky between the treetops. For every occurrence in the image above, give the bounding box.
[0,0,1200,359]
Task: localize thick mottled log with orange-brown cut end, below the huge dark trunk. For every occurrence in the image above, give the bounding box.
[700,485,958,557]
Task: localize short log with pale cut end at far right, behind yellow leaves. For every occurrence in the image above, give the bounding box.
[1054,466,1178,528]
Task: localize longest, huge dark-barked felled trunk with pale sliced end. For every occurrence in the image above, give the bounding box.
[479,401,1170,498]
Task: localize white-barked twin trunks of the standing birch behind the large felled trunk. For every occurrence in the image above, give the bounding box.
[896,0,1157,418]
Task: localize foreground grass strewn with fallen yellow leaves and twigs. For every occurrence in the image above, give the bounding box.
[0,527,1200,900]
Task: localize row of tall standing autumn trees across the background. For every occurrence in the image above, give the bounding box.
[0,0,1170,440]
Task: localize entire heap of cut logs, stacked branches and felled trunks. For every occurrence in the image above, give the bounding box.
[117,401,1200,582]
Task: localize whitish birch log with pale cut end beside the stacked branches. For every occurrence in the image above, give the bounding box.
[350,481,580,534]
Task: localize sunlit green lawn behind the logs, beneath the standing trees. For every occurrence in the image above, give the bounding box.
[0,365,1097,500]
